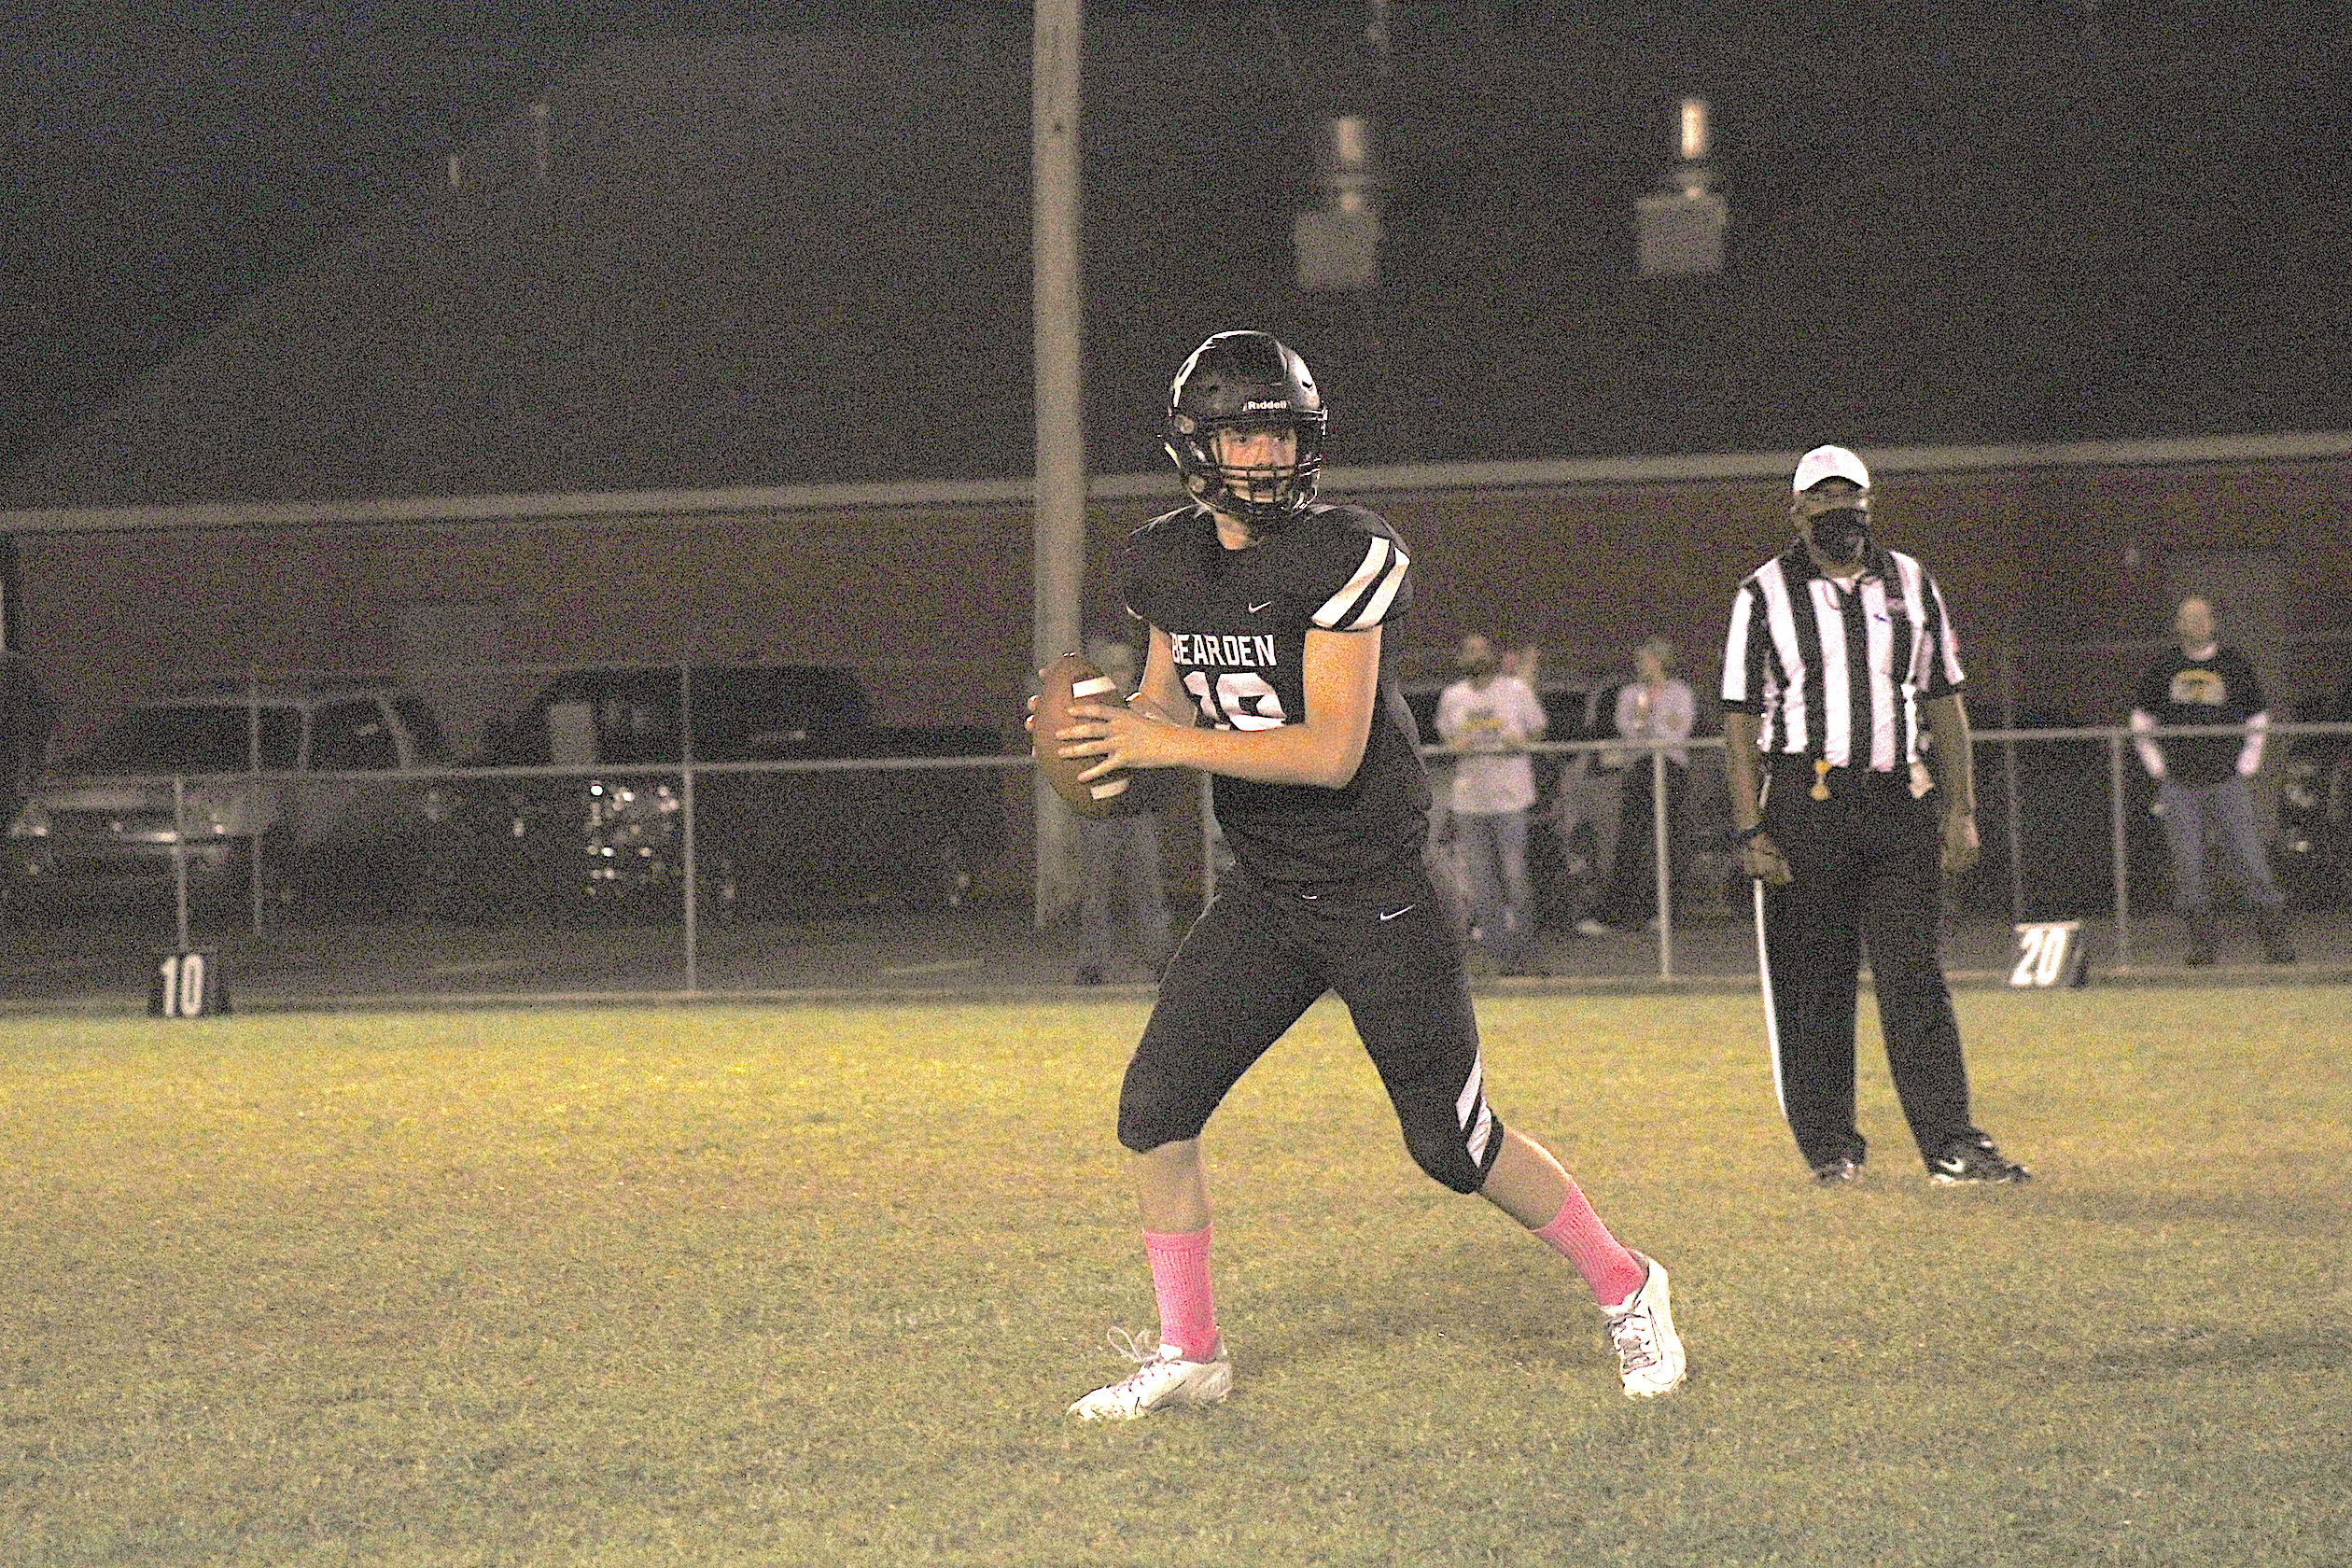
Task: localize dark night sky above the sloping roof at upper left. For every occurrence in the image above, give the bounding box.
[0,0,597,452]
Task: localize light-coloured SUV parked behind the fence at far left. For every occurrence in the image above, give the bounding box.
[7,681,444,912]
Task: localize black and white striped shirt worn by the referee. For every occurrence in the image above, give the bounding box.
[1724,540,1964,774]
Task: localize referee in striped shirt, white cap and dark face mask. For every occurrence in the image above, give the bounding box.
[1724,447,2027,1184]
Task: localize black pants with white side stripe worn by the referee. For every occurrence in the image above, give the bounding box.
[1757,760,1976,1166]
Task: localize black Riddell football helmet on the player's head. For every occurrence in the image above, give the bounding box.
[1164,331,1326,529]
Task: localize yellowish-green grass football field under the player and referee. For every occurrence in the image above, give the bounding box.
[0,987,2352,1568]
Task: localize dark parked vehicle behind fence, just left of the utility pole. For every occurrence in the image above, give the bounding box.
[428,665,1007,921]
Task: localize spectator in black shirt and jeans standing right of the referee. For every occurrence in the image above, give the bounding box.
[2131,595,2296,964]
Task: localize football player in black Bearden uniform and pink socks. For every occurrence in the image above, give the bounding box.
[1054,331,1684,1420]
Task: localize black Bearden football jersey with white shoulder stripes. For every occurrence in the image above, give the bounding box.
[1120,506,1430,882]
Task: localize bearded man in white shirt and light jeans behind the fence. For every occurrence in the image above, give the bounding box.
[1437,633,1546,975]
